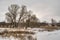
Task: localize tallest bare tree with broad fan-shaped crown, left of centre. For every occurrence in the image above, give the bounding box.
[8,4,19,22]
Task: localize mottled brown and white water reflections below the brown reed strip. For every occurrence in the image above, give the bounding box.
[0,34,36,40]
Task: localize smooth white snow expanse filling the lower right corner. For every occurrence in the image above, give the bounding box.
[36,30,60,40]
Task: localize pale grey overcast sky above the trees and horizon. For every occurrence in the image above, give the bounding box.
[0,0,60,22]
